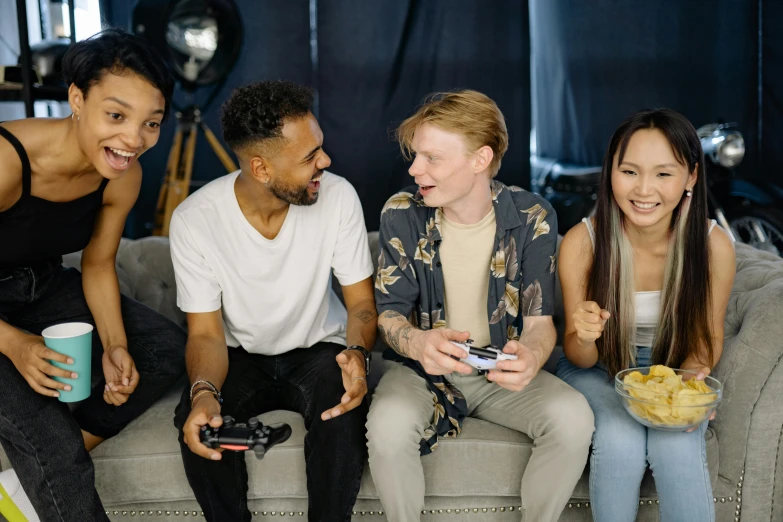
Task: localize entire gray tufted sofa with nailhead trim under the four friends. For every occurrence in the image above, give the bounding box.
[0,234,783,522]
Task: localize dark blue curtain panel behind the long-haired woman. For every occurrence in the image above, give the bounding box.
[530,0,760,176]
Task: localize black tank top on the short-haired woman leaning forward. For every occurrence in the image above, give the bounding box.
[0,127,109,269]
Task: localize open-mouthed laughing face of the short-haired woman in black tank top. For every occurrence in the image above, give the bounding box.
[68,71,165,179]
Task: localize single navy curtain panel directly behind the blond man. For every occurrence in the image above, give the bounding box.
[318,0,530,230]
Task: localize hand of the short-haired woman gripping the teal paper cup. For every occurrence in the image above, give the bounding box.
[6,333,78,397]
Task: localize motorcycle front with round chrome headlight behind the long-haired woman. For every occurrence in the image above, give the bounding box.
[697,123,783,256]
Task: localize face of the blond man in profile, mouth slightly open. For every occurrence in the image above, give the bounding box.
[408,123,489,208]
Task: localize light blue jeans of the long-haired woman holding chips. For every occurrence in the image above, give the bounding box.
[557,347,715,522]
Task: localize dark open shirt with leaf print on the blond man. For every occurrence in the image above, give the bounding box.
[375,180,557,455]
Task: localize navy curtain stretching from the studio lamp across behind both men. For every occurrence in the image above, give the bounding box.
[109,0,530,237]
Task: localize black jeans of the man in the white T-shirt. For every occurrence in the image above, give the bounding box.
[174,343,368,522]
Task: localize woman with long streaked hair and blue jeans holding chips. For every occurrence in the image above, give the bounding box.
[557,109,735,522]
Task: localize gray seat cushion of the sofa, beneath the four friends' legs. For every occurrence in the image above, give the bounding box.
[81,380,718,508]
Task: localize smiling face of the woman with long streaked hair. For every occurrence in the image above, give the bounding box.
[612,129,697,228]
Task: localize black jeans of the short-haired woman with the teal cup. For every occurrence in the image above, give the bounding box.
[0,258,187,522]
